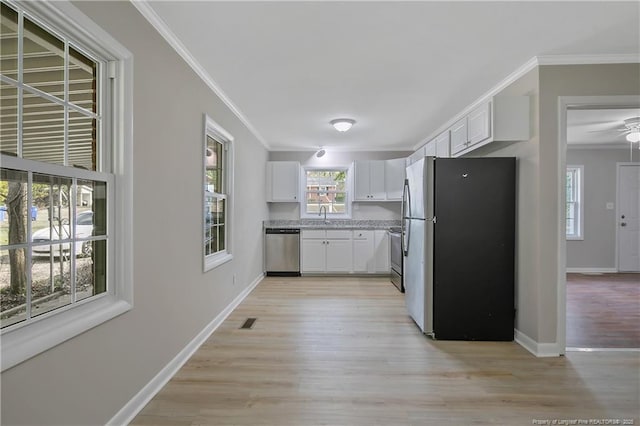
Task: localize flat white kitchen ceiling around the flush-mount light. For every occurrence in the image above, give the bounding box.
[141,1,640,150]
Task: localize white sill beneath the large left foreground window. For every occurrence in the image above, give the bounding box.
[2,296,132,371]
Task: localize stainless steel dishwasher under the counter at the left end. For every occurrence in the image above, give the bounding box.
[264,228,300,277]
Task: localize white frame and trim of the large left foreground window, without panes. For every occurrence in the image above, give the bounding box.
[1,0,133,371]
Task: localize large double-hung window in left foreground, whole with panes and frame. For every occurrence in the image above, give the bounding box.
[0,1,132,370]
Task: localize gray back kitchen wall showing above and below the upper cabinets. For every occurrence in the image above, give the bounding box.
[269,149,411,220]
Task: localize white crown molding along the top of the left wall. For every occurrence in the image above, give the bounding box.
[131,0,270,150]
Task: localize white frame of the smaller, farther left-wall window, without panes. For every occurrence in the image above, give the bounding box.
[202,114,235,272]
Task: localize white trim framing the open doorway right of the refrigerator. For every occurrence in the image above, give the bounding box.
[556,95,640,355]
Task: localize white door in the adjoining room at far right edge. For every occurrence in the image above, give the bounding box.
[616,163,640,272]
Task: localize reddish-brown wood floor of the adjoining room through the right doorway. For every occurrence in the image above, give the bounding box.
[567,274,640,348]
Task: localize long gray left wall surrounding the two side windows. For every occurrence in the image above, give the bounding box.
[1,2,268,425]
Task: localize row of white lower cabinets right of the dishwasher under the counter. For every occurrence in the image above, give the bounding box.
[300,229,390,274]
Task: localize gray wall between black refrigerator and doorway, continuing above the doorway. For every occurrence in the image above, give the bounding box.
[471,64,640,343]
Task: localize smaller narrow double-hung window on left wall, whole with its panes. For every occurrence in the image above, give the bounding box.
[204,116,233,271]
